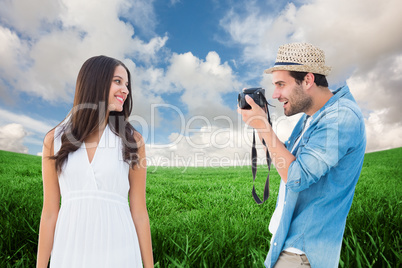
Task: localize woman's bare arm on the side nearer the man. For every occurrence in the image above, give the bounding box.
[129,133,154,268]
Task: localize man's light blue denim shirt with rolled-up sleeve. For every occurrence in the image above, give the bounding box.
[265,86,366,268]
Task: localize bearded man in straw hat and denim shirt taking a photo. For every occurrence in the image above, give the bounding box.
[238,43,366,268]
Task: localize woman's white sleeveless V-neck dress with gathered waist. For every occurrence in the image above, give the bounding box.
[50,126,142,268]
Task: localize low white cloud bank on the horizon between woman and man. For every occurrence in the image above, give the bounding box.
[146,109,300,168]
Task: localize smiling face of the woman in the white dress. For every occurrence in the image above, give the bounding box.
[108,65,129,112]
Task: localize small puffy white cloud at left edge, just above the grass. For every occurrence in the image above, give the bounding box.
[0,124,28,153]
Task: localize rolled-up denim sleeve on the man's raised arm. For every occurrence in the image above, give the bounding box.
[286,107,364,192]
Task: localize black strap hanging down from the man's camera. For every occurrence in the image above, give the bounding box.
[251,100,272,205]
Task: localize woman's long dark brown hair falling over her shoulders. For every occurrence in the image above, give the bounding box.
[51,56,138,173]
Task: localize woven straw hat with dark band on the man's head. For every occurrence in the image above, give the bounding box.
[264,43,331,76]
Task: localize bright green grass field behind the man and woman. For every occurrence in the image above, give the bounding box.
[0,148,402,267]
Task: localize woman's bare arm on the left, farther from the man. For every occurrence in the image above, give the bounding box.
[36,130,60,268]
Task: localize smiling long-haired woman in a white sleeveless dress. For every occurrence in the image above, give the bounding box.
[37,56,153,268]
